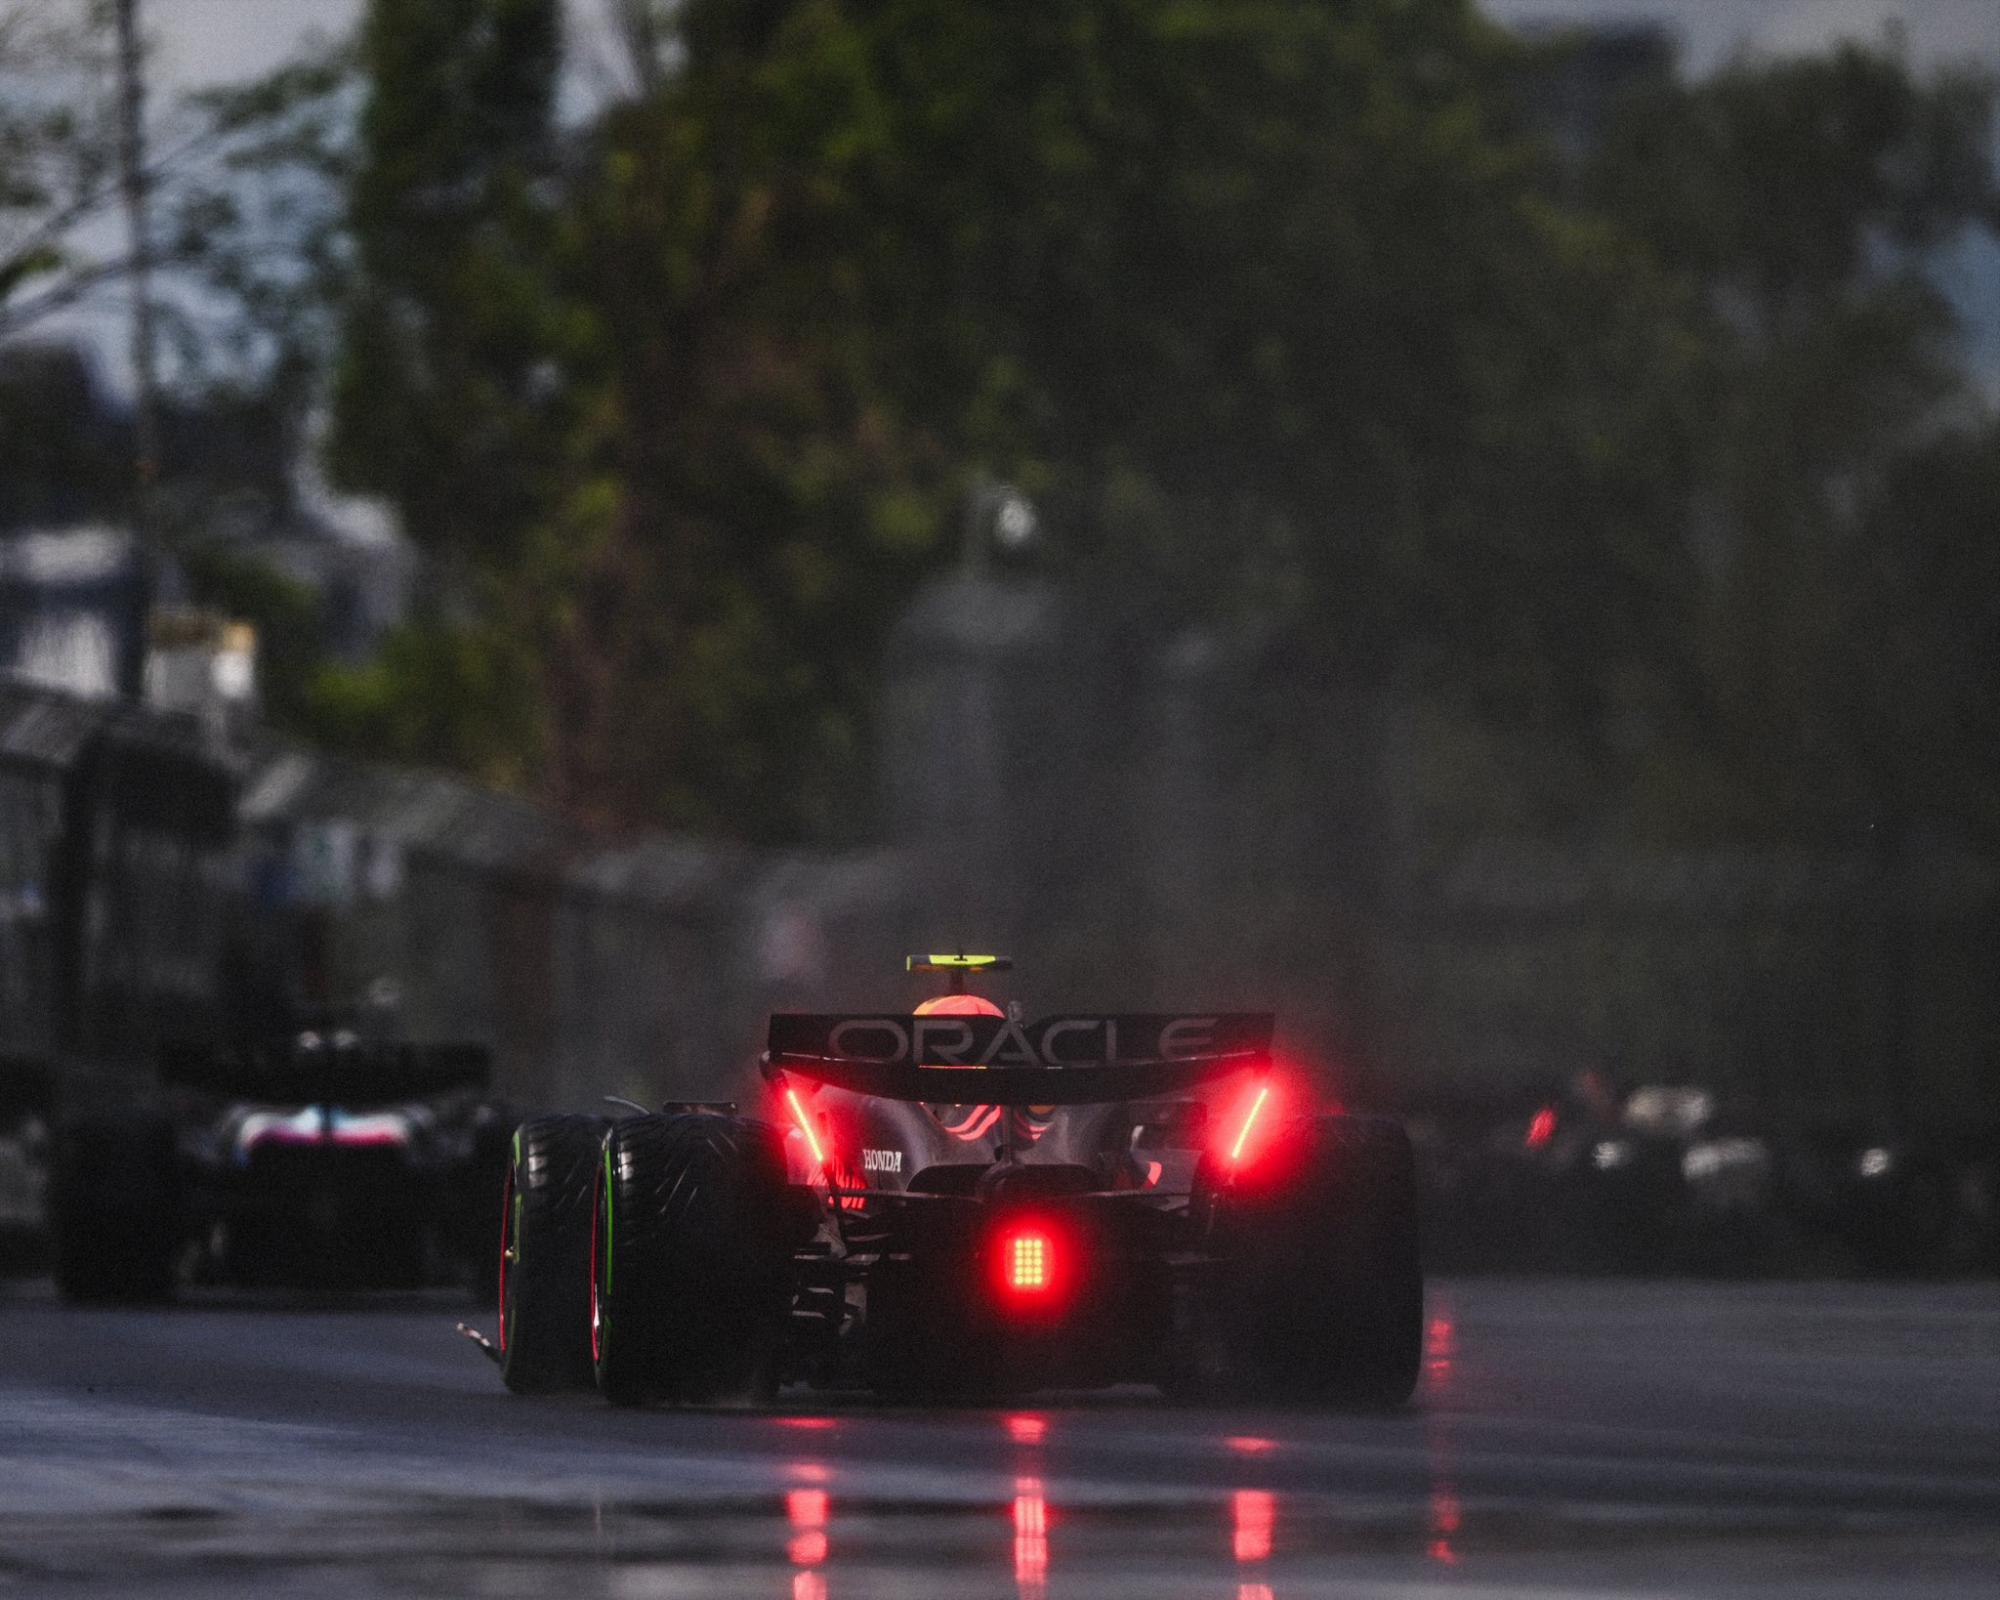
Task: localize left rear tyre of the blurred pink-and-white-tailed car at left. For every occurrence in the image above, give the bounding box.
[48,1112,180,1302]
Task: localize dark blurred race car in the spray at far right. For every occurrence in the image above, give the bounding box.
[1412,1074,2000,1276]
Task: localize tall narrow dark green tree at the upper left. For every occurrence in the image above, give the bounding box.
[332,0,562,572]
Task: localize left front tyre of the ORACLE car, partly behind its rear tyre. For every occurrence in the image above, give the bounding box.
[496,1116,604,1394]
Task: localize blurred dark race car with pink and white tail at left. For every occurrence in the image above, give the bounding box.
[48,1030,514,1300]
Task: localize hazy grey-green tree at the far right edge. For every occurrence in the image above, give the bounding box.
[1590,46,2000,840]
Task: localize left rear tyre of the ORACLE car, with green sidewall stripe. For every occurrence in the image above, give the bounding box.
[592,1112,794,1406]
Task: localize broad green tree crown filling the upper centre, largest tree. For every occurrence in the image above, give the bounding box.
[556,0,1720,834]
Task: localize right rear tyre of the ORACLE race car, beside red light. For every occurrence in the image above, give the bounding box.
[1194,1116,1424,1406]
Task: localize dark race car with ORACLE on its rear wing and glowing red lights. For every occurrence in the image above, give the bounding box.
[494,956,1424,1406]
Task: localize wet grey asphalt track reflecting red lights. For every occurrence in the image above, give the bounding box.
[0,1280,2000,1600]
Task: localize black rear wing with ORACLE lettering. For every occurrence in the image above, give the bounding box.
[764,1012,1276,1106]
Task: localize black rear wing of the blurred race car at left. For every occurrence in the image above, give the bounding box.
[160,1036,492,1106]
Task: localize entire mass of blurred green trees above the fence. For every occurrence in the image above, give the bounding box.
[47,0,2000,838]
